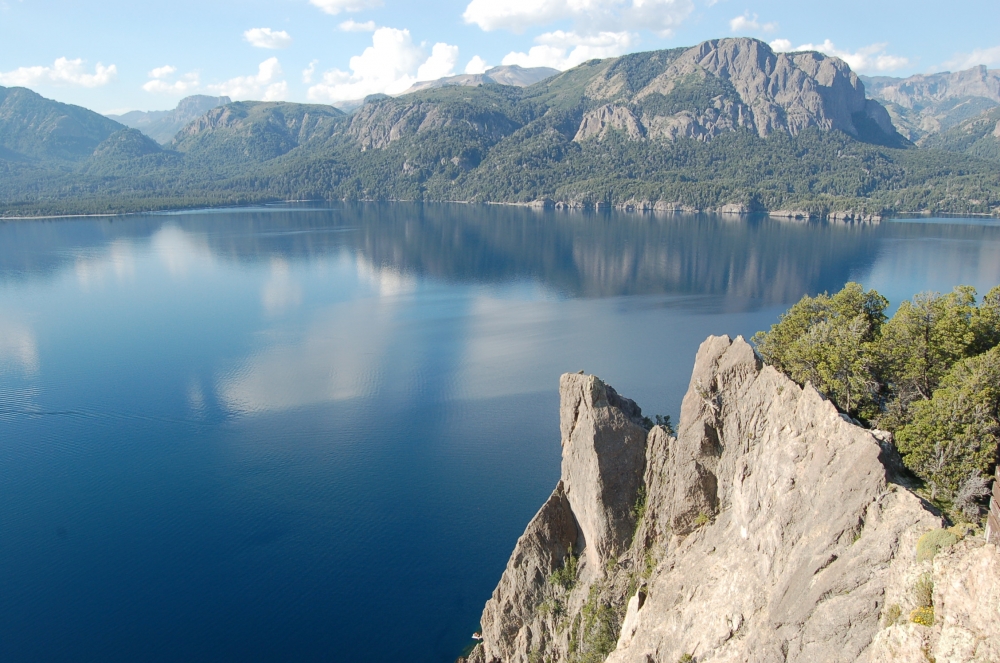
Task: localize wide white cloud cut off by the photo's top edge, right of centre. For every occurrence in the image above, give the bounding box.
[462,0,694,36]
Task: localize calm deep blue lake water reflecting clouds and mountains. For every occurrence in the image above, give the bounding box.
[0,204,1000,663]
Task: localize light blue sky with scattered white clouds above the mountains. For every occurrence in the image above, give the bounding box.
[0,0,1000,113]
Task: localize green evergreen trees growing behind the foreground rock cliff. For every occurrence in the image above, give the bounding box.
[753,283,1000,517]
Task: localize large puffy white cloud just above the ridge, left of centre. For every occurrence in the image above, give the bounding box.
[309,28,458,103]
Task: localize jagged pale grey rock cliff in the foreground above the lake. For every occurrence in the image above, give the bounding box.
[469,337,1000,663]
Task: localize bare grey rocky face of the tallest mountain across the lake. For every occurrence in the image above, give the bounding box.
[575,38,897,141]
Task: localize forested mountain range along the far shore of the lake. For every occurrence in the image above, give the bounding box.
[0,38,1000,218]
